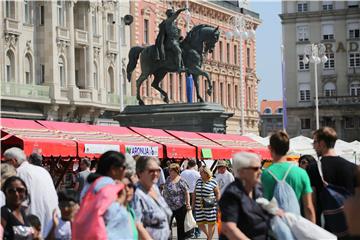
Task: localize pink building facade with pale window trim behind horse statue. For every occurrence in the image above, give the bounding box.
[130,0,261,134]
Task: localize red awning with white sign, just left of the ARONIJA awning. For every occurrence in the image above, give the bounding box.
[37,121,121,158]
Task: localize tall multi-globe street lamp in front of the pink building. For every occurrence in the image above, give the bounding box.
[225,15,255,135]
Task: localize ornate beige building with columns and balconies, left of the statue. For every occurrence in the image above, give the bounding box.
[0,0,133,124]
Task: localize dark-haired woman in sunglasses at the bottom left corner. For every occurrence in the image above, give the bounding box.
[1,176,33,240]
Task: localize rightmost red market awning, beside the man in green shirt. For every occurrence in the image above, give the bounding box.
[199,133,271,159]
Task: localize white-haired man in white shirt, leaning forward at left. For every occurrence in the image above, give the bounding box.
[4,147,58,239]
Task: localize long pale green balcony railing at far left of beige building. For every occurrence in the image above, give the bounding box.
[1,82,50,100]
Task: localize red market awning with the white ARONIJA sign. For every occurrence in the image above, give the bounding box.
[91,125,164,158]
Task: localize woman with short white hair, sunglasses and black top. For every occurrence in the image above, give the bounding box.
[219,153,271,239]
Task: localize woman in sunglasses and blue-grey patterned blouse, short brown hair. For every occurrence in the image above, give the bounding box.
[134,156,172,240]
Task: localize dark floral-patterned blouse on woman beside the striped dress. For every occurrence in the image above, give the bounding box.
[163,177,189,211]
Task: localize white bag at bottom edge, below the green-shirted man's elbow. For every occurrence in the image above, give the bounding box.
[285,213,337,240]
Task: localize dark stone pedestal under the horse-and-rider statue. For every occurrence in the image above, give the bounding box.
[114,103,233,133]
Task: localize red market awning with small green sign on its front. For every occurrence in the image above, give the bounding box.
[165,130,232,159]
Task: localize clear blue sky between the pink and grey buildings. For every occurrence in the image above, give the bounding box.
[249,1,282,102]
